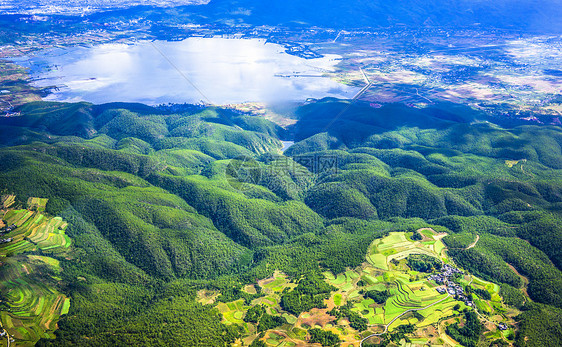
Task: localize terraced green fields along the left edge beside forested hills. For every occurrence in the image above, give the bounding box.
[0,198,71,346]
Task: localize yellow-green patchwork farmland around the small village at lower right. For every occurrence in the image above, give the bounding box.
[213,229,514,347]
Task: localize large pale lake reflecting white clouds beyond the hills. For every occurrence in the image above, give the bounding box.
[18,38,359,105]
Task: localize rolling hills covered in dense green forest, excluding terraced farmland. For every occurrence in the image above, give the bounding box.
[0,99,562,346]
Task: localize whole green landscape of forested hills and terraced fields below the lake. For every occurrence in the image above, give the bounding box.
[0,98,562,346]
